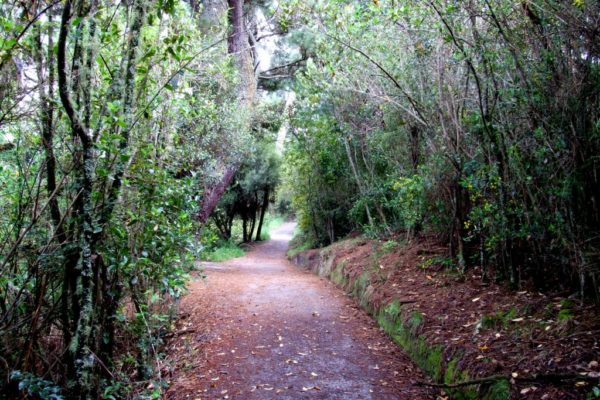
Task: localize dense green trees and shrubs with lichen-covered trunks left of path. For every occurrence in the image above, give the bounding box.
[0,0,247,398]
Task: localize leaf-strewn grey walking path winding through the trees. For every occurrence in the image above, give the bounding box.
[167,223,435,400]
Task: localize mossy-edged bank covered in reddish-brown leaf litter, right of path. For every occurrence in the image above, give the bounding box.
[293,236,600,400]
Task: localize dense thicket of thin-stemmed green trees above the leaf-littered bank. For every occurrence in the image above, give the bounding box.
[282,0,600,297]
